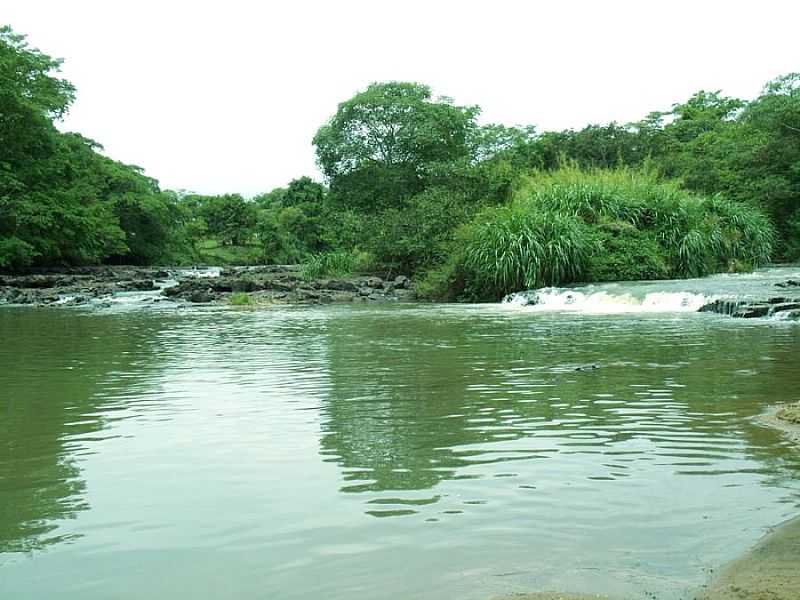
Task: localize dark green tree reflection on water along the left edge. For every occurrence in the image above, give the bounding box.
[0,309,166,552]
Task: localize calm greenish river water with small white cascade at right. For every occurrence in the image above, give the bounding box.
[0,269,800,600]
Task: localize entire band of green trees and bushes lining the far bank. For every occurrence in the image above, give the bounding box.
[0,28,800,299]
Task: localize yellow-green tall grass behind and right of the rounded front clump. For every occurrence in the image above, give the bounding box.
[514,166,775,279]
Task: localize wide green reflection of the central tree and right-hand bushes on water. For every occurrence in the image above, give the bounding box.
[321,311,800,502]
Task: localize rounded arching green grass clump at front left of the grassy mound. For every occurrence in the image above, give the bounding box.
[463,206,591,299]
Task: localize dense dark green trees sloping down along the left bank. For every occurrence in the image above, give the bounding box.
[0,27,190,268]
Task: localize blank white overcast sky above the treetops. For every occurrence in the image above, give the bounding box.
[0,0,800,195]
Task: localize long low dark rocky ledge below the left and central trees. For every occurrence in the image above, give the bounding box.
[0,265,415,306]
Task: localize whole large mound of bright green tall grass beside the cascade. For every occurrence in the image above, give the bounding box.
[432,166,775,300]
